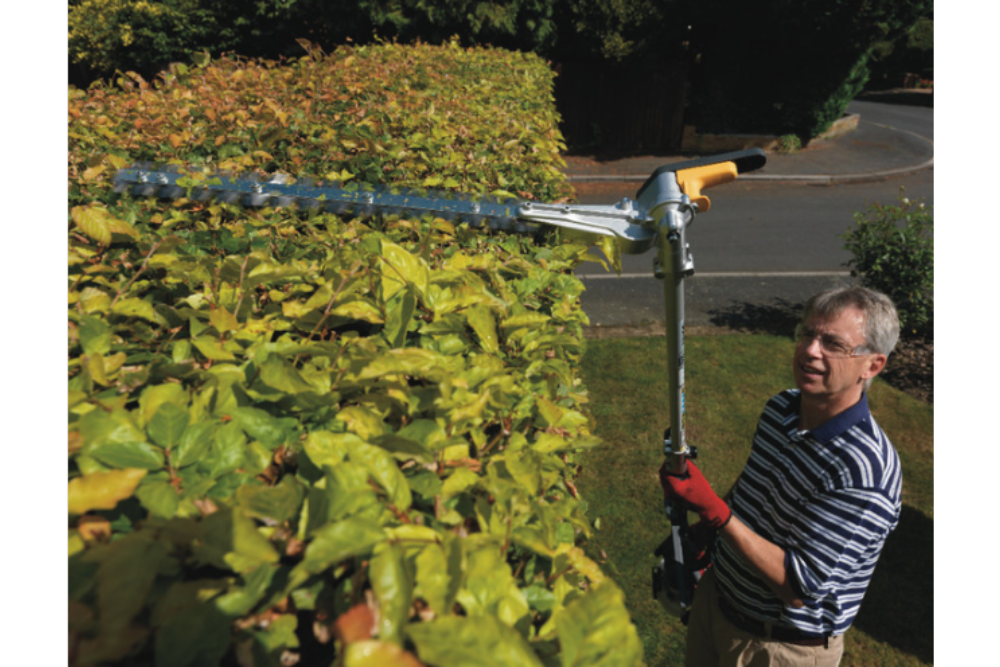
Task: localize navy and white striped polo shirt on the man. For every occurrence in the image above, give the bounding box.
[715,389,903,635]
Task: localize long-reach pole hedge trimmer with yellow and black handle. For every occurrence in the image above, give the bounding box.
[115,149,766,618]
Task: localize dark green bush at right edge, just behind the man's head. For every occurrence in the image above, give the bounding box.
[843,196,934,336]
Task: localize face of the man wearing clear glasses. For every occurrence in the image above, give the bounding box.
[792,307,886,407]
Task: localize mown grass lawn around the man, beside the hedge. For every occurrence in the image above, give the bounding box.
[578,335,934,667]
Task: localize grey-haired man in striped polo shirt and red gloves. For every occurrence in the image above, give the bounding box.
[660,287,902,667]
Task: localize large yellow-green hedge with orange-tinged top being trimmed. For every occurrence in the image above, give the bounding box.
[68,45,642,666]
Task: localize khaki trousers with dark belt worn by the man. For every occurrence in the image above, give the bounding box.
[684,567,844,667]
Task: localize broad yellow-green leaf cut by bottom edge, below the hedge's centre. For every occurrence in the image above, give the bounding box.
[407,616,548,667]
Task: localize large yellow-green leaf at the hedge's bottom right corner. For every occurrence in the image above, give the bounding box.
[555,579,642,667]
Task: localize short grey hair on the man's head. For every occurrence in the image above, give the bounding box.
[802,285,899,390]
